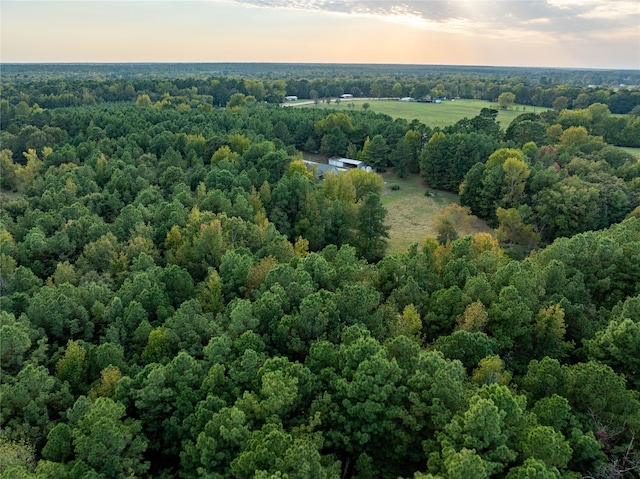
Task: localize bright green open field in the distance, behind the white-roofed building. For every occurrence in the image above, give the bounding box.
[292,99,546,129]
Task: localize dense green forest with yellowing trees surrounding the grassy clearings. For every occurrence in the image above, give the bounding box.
[0,65,640,479]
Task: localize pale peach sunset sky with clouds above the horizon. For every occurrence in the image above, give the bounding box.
[0,0,640,69]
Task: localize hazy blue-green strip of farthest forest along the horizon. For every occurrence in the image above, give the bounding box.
[1,63,640,87]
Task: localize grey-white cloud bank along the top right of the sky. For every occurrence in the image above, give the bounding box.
[222,0,640,37]
